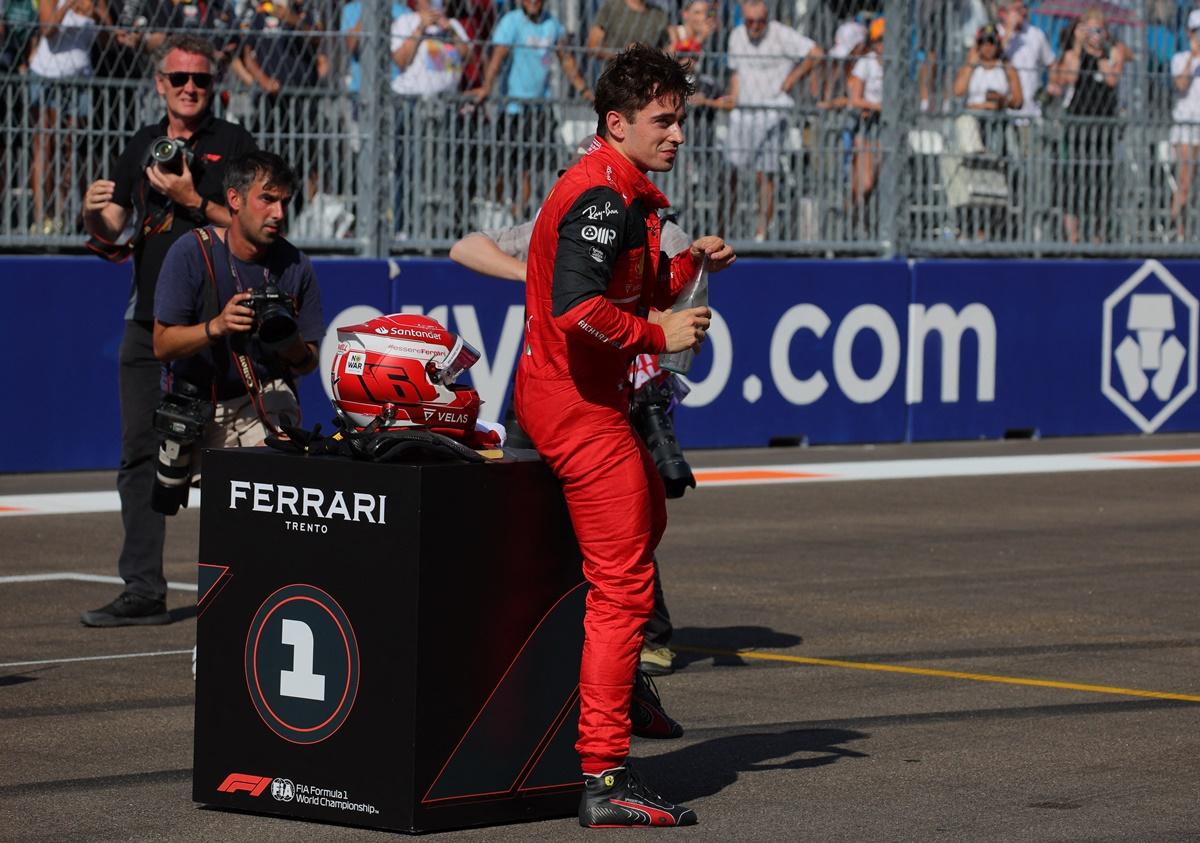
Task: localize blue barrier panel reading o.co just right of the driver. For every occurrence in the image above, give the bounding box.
[676,259,910,448]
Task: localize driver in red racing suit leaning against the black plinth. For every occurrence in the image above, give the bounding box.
[516,43,734,827]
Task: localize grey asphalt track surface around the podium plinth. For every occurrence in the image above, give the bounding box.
[0,436,1200,843]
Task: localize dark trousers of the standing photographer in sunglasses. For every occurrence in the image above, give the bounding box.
[116,321,167,599]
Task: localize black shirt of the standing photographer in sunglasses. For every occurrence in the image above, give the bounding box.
[113,114,256,322]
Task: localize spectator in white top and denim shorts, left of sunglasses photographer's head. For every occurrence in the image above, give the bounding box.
[29,0,108,234]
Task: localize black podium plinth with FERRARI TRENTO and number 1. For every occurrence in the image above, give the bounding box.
[192,449,586,831]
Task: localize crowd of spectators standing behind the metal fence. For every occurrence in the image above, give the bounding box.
[0,0,1200,243]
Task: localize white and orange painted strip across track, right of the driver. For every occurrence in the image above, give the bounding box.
[694,450,1200,489]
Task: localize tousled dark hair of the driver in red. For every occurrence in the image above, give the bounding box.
[595,43,696,137]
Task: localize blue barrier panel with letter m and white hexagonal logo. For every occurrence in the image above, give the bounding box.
[907,261,1200,441]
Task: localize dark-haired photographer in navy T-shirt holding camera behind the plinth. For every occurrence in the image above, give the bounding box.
[154,151,324,468]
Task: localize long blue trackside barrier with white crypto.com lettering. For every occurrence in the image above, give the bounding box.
[0,257,1200,472]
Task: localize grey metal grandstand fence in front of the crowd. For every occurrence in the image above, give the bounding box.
[7,0,1200,257]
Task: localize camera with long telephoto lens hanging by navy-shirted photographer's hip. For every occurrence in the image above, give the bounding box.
[150,382,212,515]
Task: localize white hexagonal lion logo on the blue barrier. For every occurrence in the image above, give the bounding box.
[1100,261,1200,434]
